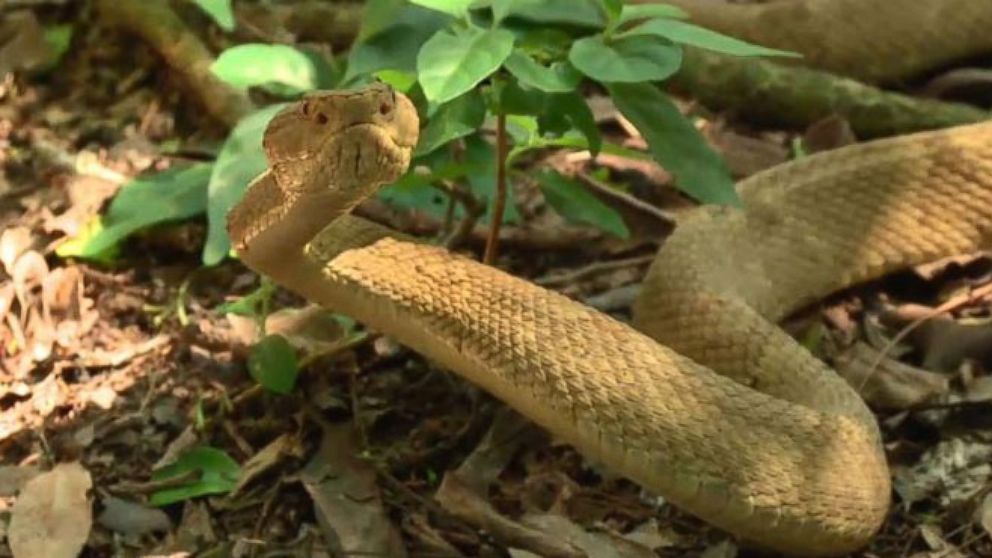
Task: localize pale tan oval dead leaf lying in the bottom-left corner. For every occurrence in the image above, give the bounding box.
[7,463,93,558]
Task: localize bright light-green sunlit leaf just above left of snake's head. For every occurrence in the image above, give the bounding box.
[210,43,321,96]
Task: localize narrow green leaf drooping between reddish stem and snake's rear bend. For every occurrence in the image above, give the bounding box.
[537,170,630,238]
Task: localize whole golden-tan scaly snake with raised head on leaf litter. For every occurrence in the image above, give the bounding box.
[228,3,992,556]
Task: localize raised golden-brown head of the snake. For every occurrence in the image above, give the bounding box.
[263,83,420,196]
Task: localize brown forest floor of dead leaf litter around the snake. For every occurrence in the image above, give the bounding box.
[0,2,992,558]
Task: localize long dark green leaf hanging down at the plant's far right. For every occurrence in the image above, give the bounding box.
[607,83,740,206]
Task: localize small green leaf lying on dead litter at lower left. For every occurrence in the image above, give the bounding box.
[149,446,241,506]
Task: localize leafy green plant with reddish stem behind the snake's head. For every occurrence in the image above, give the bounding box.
[59,0,791,394]
